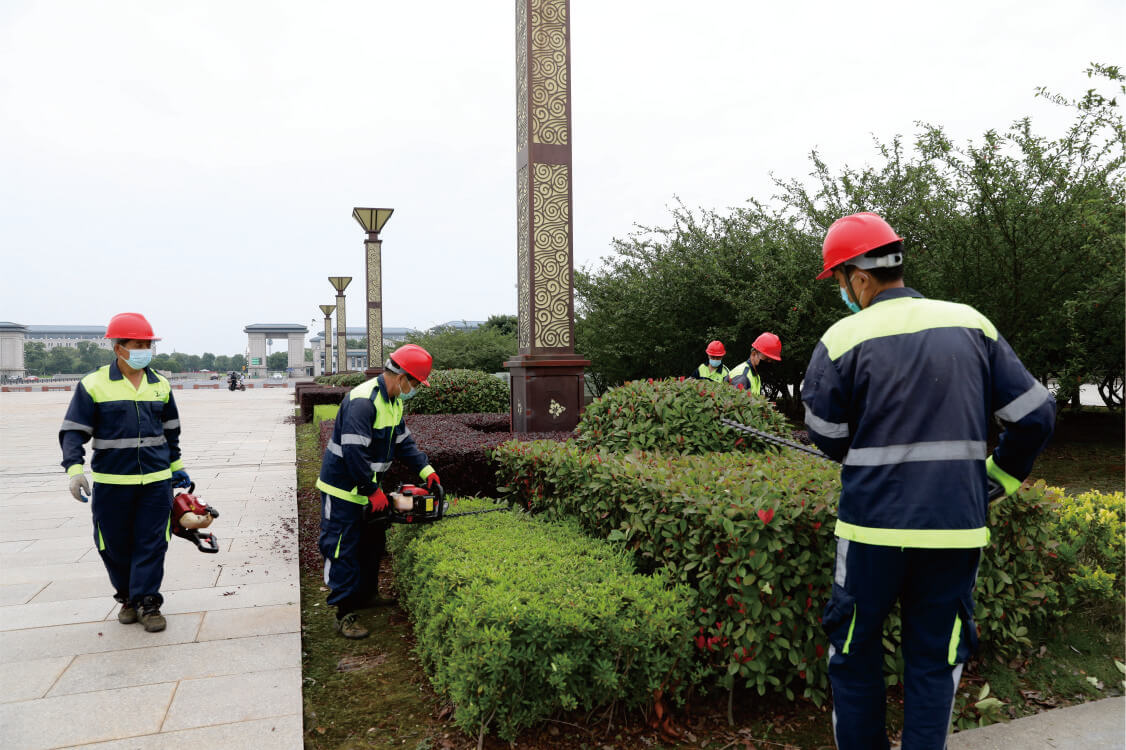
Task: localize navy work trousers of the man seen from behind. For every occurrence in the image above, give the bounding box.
[822,539,981,750]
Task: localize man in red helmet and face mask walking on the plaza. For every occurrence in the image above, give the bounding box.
[59,313,191,633]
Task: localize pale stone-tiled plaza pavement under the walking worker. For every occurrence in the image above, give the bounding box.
[0,389,302,750]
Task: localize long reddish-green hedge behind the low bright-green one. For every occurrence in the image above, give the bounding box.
[494,443,1085,705]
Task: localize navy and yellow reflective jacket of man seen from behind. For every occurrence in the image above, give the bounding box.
[802,287,1055,548]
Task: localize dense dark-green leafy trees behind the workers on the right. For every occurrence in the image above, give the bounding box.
[575,65,1126,413]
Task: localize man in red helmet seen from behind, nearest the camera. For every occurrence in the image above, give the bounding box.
[802,213,1055,750]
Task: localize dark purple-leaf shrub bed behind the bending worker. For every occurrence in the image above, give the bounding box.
[321,414,572,498]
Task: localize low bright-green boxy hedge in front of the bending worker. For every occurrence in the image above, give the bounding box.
[387,500,690,741]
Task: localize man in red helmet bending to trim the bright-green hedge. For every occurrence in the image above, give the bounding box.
[316,343,441,639]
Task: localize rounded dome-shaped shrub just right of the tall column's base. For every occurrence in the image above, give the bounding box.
[575,380,790,454]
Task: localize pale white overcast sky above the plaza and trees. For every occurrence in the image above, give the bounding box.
[0,0,1126,354]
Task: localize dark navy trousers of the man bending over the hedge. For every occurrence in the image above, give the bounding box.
[319,492,387,617]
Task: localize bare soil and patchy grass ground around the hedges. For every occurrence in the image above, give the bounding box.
[297,410,1126,750]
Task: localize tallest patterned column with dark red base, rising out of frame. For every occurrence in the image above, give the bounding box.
[504,0,590,432]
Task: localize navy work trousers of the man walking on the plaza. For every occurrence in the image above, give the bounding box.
[90,480,172,606]
